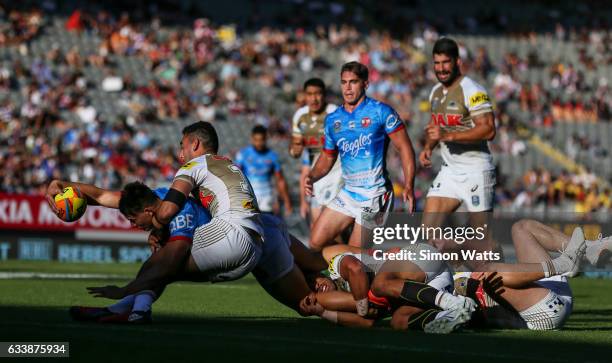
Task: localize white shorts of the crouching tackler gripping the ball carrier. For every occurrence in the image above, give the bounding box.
[191,217,262,282]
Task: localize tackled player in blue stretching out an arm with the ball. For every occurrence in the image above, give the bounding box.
[47,182,325,322]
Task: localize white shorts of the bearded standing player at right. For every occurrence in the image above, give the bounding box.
[427,166,496,212]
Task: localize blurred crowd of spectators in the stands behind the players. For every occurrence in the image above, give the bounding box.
[0,2,612,216]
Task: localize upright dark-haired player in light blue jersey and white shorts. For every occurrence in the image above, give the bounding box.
[305,62,414,250]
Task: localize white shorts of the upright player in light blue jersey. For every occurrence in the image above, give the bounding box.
[327,189,393,229]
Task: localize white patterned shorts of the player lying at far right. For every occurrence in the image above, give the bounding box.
[519,276,573,330]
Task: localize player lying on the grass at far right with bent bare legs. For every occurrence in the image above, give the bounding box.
[455,220,606,330]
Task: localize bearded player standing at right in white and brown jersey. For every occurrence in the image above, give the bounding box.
[419,38,495,225]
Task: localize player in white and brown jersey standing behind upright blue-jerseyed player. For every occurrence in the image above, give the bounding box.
[289,78,342,224]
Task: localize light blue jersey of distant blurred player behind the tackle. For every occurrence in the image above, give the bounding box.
[234,145,281,199]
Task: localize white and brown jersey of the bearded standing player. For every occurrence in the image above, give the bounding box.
[429,76,494,172]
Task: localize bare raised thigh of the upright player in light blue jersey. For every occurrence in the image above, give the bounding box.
[309,208,354,251]
